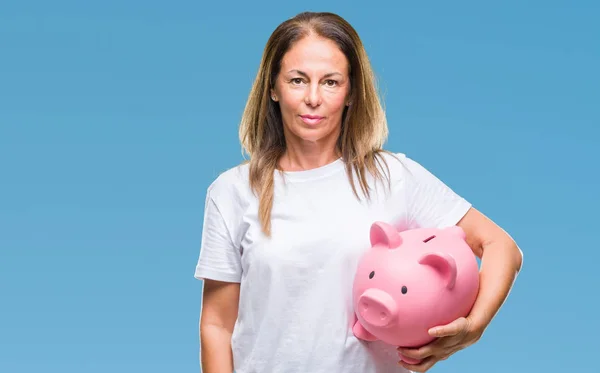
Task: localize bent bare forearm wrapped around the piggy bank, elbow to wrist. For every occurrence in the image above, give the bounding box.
[469,236,523,329]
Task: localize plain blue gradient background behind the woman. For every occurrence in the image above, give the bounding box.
[0,0,600,373]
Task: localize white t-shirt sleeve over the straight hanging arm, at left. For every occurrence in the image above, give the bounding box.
[194,193,242,282]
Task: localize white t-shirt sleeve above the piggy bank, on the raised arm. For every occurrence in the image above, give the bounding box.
[403,153,471,228]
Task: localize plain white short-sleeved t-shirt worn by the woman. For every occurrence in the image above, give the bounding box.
[194,153,471,373]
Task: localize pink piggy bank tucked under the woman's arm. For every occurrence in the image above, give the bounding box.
[352,222,479,364]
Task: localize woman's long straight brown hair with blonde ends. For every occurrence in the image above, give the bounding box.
[239,12,389,236]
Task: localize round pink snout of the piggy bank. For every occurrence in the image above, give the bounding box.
[358,289,398,327]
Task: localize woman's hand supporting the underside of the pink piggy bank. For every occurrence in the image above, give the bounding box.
[398,317,485,372]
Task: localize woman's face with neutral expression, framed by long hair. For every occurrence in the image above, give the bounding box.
[271,35,350,148]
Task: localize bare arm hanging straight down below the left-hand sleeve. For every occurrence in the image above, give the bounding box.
[200,279,240,373]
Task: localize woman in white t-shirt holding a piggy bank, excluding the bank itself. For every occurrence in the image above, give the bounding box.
[195,13,522,373]
